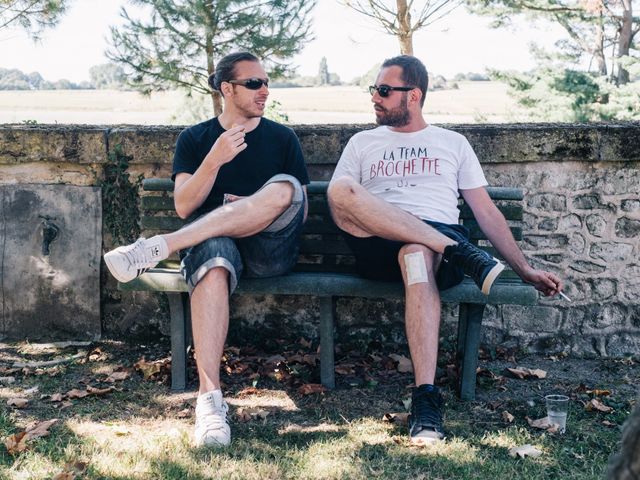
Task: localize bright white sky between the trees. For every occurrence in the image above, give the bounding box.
[0,0,561,82]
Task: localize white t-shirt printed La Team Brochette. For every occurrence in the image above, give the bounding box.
[333,125,487,224]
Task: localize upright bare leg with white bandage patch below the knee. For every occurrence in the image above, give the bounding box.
[398,244,440,386]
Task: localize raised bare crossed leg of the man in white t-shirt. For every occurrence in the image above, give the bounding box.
[327,177,457,253]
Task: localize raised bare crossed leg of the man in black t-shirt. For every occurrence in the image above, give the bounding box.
[163,182,293,252]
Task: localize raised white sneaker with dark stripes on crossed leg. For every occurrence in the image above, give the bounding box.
[104,236,169,283]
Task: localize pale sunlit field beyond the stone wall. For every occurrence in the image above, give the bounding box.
[0,82,515,125]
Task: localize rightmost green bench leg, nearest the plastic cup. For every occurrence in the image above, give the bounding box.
[457,303,485,400]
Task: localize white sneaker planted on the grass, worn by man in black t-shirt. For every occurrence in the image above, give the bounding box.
[195,390,231,447]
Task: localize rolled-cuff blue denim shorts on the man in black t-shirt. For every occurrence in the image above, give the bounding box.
[180,174,306,295]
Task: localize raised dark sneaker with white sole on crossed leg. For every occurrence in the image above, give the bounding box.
[442,242,504,295]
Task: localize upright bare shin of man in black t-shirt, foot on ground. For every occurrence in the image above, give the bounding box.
[191,268,229,394]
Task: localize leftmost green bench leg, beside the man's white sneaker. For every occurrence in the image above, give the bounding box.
[167,293,189,391]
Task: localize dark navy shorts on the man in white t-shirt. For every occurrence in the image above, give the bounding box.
[342,220,469,290]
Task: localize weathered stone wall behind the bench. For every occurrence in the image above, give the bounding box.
[0,123,640,355]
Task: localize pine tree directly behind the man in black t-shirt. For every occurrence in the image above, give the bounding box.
[107,0,316,115]
